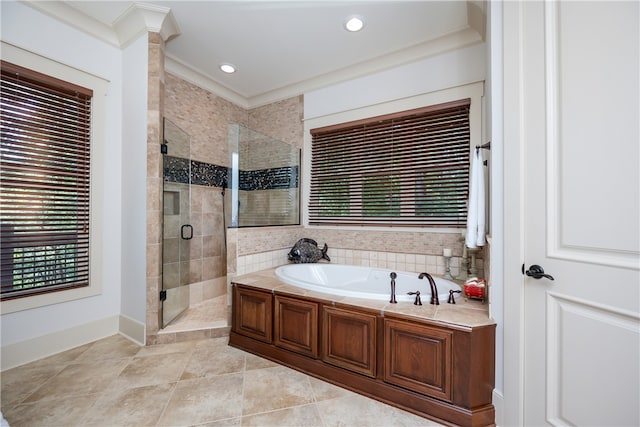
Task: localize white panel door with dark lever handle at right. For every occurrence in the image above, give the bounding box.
[516,1,640,426]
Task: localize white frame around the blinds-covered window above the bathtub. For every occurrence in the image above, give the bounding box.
[302,81,484,232]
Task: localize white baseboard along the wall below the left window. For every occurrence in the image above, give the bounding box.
[0,315,119,371]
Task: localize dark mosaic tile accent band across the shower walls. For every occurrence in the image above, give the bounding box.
[163,155,299,191]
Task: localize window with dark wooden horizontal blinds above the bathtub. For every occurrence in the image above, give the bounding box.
[308,99,470,227]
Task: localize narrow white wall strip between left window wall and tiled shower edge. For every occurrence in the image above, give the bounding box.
[120,33,149,341]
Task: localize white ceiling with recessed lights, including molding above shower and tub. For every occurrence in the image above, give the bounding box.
[31,0,485,107]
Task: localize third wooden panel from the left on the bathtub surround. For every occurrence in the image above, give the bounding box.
[322,306,376,377]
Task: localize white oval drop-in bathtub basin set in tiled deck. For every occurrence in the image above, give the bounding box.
[276,264,461,304]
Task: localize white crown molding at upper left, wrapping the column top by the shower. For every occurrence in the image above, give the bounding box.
[21,0,180,48]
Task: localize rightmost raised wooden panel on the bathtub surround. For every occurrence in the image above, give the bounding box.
[384,319,453,401]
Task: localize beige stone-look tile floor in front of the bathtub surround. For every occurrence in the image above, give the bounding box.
[0,335,439,427]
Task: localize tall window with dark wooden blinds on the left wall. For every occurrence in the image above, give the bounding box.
[0,61,93,300]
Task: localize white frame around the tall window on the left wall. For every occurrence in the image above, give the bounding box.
[0,42,108,314]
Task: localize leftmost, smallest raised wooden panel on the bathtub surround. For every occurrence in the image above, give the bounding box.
[233,286,273,342]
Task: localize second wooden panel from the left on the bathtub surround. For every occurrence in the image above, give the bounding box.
[273,295,318,358]
